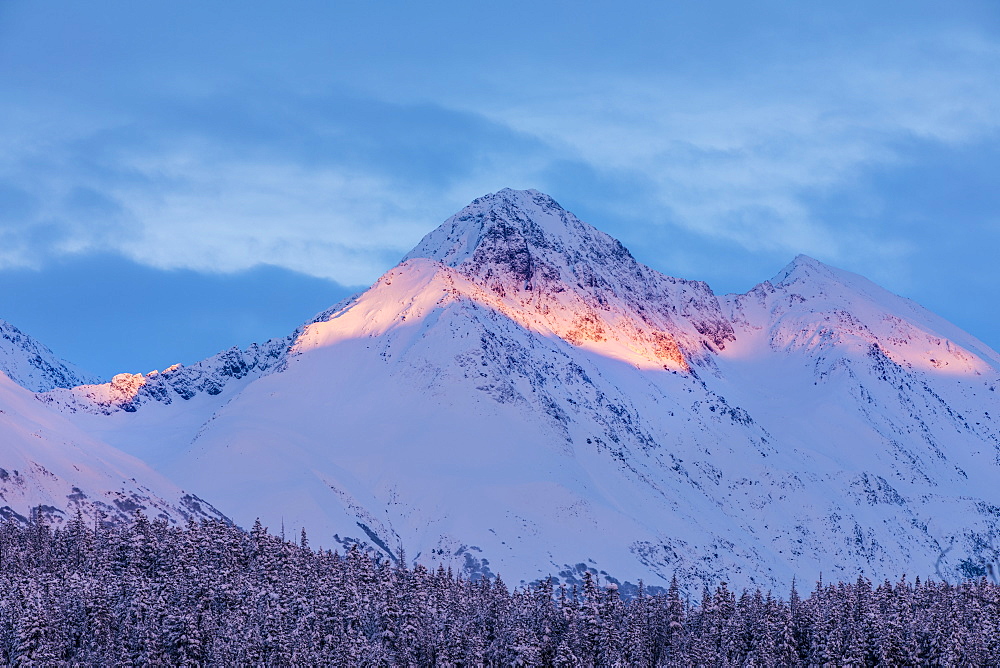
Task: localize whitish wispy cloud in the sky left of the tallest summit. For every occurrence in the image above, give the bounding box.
[0,91,552,284]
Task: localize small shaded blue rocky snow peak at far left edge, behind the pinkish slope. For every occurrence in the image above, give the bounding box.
[0,320,97,392]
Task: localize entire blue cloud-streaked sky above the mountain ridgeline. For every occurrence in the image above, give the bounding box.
[0,0,1000,376]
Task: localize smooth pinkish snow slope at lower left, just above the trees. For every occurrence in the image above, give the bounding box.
[0,373,222,524]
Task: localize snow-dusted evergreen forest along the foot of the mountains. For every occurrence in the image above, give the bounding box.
[0,516,1000,666]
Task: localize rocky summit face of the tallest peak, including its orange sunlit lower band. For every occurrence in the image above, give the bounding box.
[404,188,732,367]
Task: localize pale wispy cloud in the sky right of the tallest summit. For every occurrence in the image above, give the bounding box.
[458,33,1000,260]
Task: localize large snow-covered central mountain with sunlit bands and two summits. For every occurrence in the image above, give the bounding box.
[39,190,1000,585]
